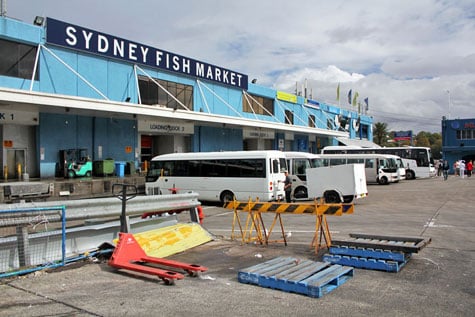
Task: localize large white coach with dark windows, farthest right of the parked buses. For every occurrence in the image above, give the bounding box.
[322,146,435,179]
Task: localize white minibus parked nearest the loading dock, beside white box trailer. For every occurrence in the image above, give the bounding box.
[145,151,287,202]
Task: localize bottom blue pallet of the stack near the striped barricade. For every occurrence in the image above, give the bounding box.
[323,254,407,272]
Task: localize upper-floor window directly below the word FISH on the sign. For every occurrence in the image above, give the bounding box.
[139,76,193,110]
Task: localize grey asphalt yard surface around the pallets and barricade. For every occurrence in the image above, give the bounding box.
[0,176,475,316]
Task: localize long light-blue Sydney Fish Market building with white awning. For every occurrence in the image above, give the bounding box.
[0,17,373,178]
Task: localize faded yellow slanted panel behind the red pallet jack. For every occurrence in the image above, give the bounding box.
[114,223,213,258]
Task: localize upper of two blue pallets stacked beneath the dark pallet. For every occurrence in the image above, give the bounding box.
[329,245,411,262]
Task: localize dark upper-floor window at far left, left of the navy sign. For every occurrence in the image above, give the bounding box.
[0,39,39,80]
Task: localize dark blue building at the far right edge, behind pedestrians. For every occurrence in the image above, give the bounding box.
[442,117,475,173]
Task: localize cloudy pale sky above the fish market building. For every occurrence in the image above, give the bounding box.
[0,0,475,133]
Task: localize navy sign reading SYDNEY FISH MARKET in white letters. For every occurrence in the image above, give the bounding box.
[46,18,248,90]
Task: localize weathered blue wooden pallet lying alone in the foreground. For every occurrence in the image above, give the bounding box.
[238,257,354,298]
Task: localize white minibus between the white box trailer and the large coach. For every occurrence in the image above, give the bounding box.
[319,154,399,185]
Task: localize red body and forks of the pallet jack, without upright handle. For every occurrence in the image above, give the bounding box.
[109,232,208,285]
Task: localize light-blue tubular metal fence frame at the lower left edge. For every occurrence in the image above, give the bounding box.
[0,206,66,278]
